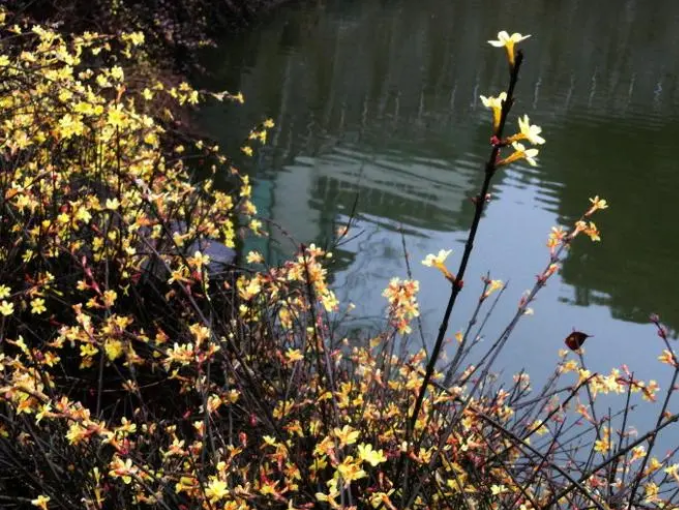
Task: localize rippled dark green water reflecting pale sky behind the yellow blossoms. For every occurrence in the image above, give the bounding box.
[199,0,679,386]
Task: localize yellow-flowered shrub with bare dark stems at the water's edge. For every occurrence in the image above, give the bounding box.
[0,10,679,510]
